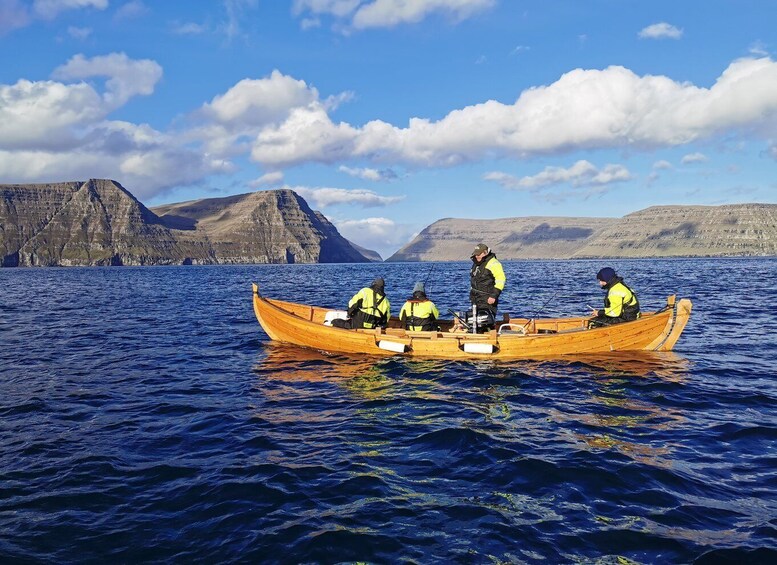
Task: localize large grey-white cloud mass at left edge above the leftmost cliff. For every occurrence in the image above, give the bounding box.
[0,54,227,197]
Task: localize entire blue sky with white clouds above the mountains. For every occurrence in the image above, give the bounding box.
[0,0,777,257]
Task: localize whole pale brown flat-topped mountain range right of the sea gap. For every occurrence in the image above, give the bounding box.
[387,204,777,261]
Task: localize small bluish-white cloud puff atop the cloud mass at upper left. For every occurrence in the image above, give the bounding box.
[52,53,162,109]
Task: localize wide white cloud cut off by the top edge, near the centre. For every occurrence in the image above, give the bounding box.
[294,0,495,29]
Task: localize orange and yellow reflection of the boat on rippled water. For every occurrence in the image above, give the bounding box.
[254,342,690,467]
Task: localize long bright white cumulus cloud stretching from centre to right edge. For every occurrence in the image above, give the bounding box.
[251,58,777,167]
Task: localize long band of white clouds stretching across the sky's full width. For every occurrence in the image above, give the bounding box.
[0,52,777,198]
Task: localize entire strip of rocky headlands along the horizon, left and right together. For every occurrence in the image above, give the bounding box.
[0,179,777,267]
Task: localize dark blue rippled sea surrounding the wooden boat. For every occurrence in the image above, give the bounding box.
[0,259,777,564]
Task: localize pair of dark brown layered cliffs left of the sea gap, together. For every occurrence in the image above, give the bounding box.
[0,179,370,267]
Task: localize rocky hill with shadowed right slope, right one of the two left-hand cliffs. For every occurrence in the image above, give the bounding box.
[152,190,367,263]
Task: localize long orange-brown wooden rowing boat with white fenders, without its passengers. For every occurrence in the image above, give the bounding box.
[253,284,692,359]
